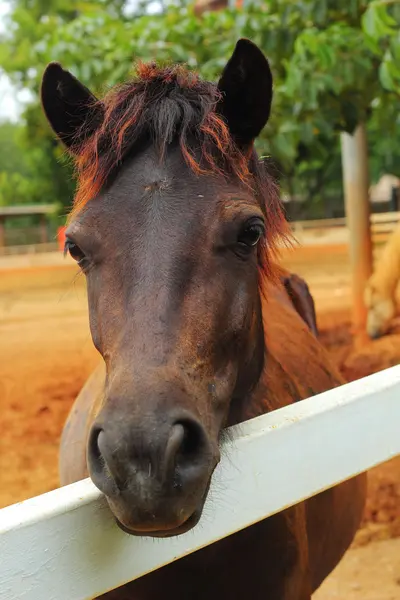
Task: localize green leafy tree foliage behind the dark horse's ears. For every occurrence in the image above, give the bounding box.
[0,0,400,212]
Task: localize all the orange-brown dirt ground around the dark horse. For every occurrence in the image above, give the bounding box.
[0,249,400,600]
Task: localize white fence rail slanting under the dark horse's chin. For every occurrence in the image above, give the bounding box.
[0,366,400,600]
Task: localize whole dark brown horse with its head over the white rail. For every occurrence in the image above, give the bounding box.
[42,40,365,600]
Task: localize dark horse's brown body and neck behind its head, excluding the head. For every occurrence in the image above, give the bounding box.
[60,274,366,600]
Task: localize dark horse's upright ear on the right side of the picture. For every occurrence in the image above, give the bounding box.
[218,39,272,147]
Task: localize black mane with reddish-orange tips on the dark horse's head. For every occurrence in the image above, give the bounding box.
[70,62,289,275]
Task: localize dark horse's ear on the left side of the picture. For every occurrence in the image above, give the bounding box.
[41,62,102,153]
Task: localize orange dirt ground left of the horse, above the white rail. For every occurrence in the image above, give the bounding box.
[0,268,98,507]
